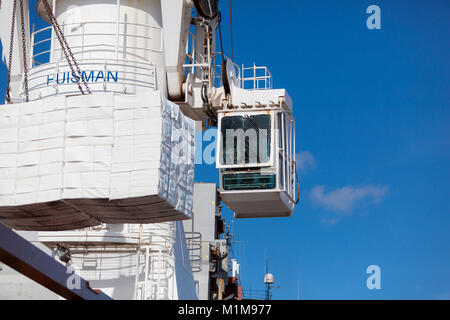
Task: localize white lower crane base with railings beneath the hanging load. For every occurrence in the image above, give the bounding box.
[38,221,197,300]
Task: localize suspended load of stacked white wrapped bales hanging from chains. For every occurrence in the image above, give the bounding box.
[0,91,194,230]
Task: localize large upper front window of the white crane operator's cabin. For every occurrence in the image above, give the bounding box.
[220,114,271,165]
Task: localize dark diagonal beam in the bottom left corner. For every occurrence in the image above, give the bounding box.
[0,223,111,300]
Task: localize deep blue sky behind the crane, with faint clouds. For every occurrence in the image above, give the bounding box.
[0,0,450,299]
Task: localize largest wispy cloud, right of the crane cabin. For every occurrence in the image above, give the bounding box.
[310,185,389,214]
